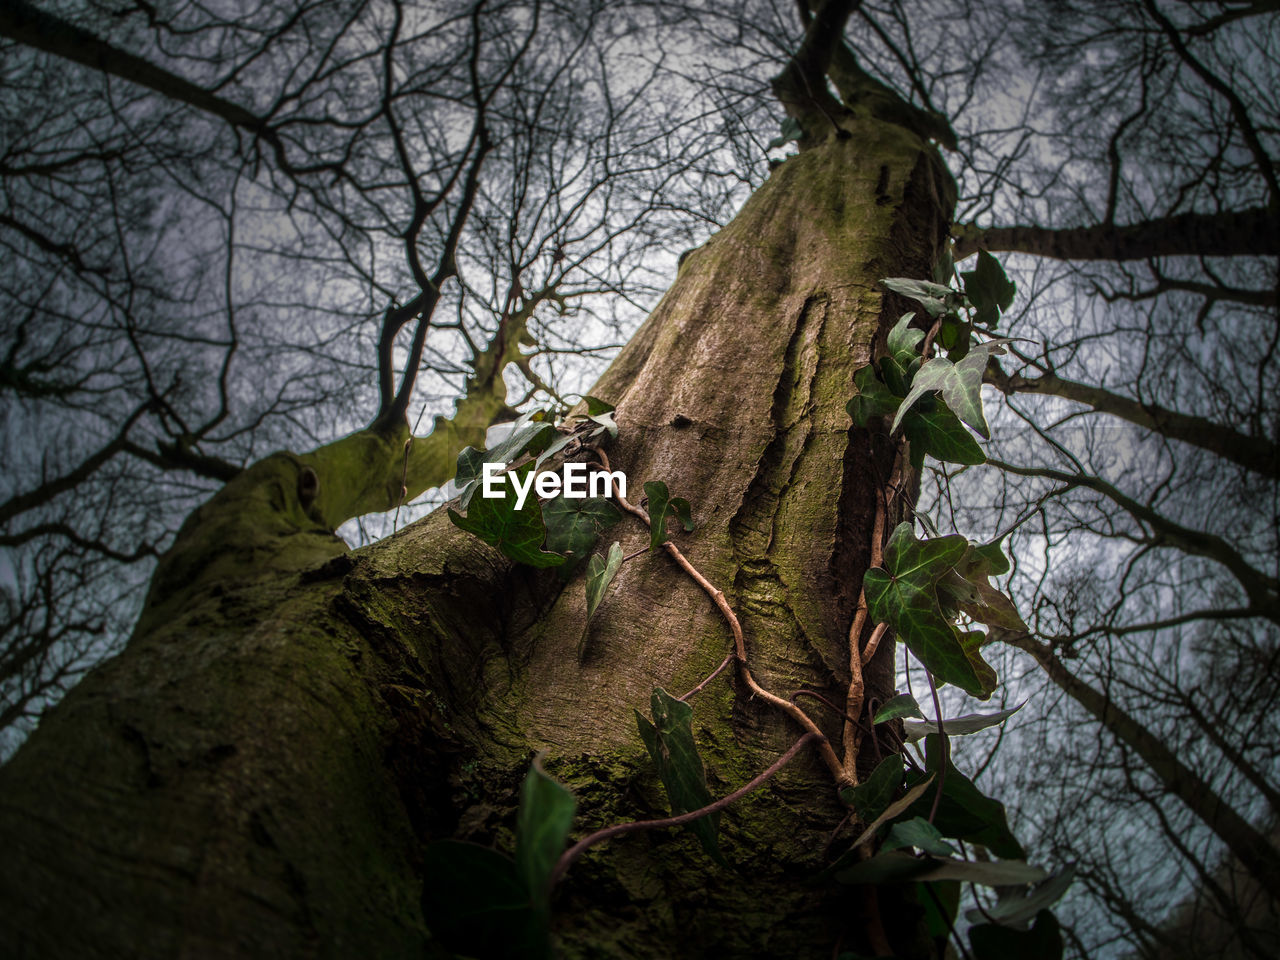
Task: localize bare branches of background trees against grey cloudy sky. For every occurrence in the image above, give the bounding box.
[0,0,1280,957]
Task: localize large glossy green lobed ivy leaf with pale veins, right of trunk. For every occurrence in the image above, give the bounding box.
[863,524,996,700]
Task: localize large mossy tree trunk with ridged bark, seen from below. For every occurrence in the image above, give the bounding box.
[0,119,954,959]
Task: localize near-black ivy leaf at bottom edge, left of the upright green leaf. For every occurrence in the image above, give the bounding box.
[421,840,550,960]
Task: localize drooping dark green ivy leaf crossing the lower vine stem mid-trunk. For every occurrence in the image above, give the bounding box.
[636,686,724,864]
